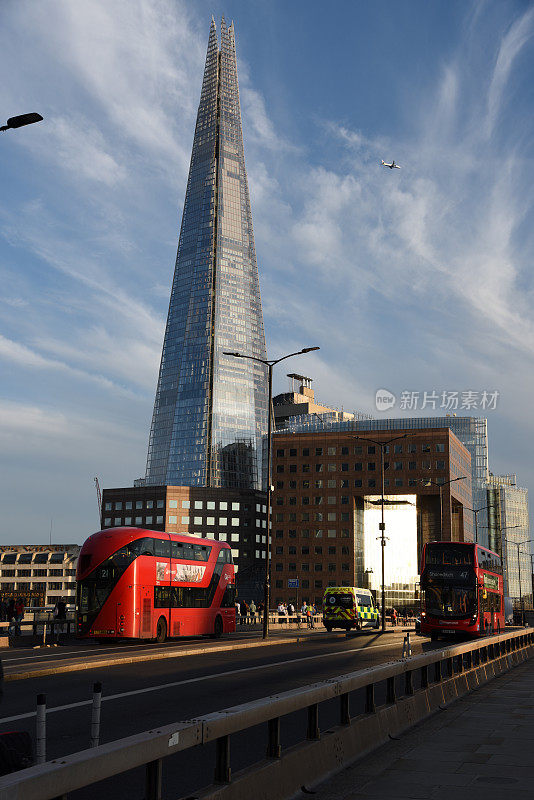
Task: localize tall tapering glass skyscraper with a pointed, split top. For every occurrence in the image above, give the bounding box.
[145,19,267,489]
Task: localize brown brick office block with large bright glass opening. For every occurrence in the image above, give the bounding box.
[271,428,472,608]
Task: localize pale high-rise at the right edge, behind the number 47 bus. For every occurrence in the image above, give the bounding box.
[487,473,532,608]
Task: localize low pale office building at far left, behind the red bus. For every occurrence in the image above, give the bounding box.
[0,544,81,608]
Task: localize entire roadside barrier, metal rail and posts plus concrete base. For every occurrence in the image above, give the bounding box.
[0,631,534,800]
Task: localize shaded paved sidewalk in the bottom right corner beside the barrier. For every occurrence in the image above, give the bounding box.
[313,662,534,800]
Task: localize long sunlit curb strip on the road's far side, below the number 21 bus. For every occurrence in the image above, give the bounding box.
[4,630,410,683]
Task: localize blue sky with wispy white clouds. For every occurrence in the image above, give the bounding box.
[0,0,534,542]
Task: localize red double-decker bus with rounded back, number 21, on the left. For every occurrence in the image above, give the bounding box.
[76,528,236,642]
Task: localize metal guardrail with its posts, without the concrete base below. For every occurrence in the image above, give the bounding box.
[0,631,534,800]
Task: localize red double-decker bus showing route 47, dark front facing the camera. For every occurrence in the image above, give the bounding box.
[421,542,504,639]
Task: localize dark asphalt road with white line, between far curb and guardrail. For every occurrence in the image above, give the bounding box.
[0,632,443,800]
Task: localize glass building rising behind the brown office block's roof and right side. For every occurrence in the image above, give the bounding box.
[285,413,489,545]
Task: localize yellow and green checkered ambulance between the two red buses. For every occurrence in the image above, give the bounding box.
[323,586,380,631]
